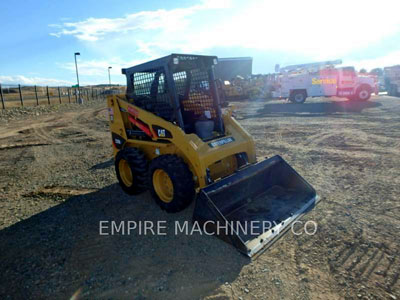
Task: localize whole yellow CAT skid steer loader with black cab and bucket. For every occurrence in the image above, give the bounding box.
[107,54,318,257]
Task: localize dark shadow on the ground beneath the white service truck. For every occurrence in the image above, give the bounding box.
[239,101,382,119]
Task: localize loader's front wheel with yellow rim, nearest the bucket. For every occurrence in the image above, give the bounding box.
[149,154,196,213]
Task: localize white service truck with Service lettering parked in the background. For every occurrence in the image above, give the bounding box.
[272,60,379,103]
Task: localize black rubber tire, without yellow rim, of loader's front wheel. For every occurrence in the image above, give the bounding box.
[149,154,196,213]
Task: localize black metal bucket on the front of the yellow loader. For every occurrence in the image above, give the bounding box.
[193,156,319,257]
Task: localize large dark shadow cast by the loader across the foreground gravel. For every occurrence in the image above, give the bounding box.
[0,184,250,299]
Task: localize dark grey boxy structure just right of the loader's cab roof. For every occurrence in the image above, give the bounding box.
[215,57,253,81]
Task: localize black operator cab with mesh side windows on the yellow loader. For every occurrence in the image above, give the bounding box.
[122,54,224,140]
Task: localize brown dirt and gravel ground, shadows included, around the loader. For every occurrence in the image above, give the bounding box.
[0,96,400,300]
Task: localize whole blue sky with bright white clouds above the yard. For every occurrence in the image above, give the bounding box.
[0,0,400,86]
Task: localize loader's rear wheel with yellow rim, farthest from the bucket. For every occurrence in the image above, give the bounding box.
[115,148,147,195]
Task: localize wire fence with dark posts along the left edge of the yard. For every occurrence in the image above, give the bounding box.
[0,84,125,109]
